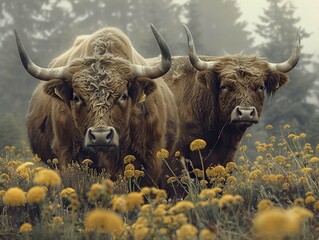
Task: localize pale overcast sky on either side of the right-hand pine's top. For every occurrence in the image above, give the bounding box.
[237,0,319,61]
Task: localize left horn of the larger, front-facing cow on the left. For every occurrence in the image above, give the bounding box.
[14,30,68,81]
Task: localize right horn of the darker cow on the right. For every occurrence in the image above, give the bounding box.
[268,29,301,73]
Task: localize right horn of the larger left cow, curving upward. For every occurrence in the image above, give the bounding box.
[134,24,172,79]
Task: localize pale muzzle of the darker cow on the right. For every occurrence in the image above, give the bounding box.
[230,106,258,126]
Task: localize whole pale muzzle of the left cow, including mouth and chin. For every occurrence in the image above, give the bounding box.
[85,127,119,148]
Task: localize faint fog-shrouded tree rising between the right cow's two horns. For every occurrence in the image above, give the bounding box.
[186,0,252,56]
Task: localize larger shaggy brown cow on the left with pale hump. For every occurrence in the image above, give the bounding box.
[16,25,178,185]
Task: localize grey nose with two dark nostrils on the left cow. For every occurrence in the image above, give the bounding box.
[87,127,116,146]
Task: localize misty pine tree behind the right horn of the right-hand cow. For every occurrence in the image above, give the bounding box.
[256,0,315,139]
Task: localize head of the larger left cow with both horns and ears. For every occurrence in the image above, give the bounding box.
[16,25,171,168]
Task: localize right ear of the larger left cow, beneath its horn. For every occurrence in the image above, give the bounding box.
[129,78,157,104]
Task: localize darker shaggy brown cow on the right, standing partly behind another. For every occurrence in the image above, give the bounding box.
[159,26,300,182]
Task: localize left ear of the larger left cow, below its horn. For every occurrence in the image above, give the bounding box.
[43,79,72,105]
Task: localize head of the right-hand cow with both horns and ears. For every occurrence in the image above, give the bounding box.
[184,25,301,129]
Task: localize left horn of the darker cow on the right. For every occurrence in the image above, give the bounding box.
[183,24,216,71]
